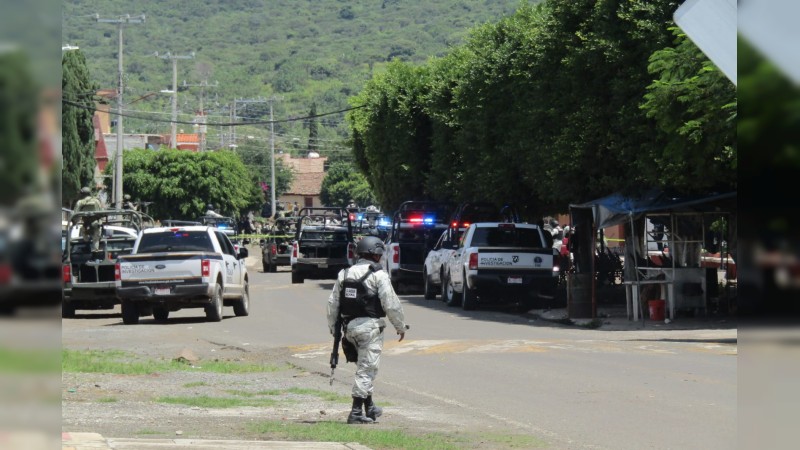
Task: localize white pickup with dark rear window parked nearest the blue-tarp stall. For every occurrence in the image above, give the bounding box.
[442,222,559,312]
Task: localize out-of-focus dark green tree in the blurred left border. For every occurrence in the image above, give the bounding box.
[0,51,39,205]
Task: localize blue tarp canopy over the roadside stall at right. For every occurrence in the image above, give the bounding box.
[569,190,736,229]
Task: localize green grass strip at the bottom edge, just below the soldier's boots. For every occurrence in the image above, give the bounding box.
[248,421,467,450]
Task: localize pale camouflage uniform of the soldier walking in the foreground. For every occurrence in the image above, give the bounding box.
[328,259,406,398]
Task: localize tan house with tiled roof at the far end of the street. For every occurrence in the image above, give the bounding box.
[275,153,328,209]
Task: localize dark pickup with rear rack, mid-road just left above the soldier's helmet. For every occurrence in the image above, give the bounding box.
[290,208,356,283]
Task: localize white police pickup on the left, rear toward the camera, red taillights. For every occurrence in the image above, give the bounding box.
[115,226,250,324]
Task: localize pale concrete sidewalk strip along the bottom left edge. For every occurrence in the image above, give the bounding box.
[61,432,370,450]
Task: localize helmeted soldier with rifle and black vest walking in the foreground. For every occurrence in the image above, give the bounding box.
[328,236,408,423]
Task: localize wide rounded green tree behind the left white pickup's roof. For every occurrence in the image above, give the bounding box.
[122,149,260,220]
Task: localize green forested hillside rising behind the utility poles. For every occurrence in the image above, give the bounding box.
[62,0,519,154]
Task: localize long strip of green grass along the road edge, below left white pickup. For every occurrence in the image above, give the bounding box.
[61,350,283,375]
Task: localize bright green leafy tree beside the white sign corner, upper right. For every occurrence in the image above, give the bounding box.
[639,27,737,192]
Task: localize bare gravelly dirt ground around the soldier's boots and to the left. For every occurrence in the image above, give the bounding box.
[62,349,532,450]
